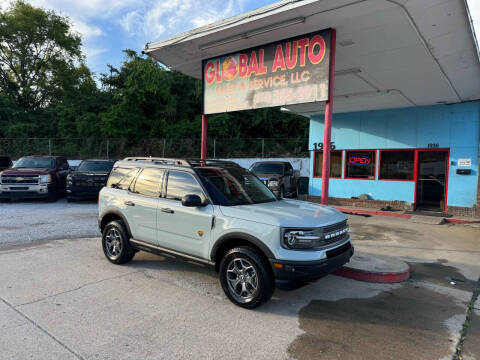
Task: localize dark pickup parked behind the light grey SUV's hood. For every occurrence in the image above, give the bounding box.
[250,161,300,198]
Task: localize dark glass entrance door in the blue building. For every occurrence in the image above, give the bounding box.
[416,150,448,211]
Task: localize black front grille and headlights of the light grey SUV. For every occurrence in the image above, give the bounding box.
[282,224,348,249]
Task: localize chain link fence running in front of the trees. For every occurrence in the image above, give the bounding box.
[0,138,308,159]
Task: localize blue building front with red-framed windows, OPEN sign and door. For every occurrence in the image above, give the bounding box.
[309,101,480,216]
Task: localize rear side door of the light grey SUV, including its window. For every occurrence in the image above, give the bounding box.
[124,168,164,245]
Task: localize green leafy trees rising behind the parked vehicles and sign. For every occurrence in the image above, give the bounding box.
[0,0,308,151]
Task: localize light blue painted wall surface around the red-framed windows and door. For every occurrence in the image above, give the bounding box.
[309,101,480,207]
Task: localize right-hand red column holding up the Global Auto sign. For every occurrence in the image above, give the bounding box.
[322,29,337,205]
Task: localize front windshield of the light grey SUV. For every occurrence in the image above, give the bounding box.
[196,167,277,206]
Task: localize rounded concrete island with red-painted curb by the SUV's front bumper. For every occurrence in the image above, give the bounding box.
[333,253,410,283]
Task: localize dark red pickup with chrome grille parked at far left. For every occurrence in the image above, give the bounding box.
[0,156,69,202]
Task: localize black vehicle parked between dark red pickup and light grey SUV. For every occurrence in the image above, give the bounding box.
[67,160,115,201]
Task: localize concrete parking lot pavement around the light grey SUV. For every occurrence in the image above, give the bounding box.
[0,200,480,359]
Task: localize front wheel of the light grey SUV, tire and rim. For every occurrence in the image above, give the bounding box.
[219,246,275,309]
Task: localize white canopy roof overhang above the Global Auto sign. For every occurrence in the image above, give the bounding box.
[144,0,480,114]
